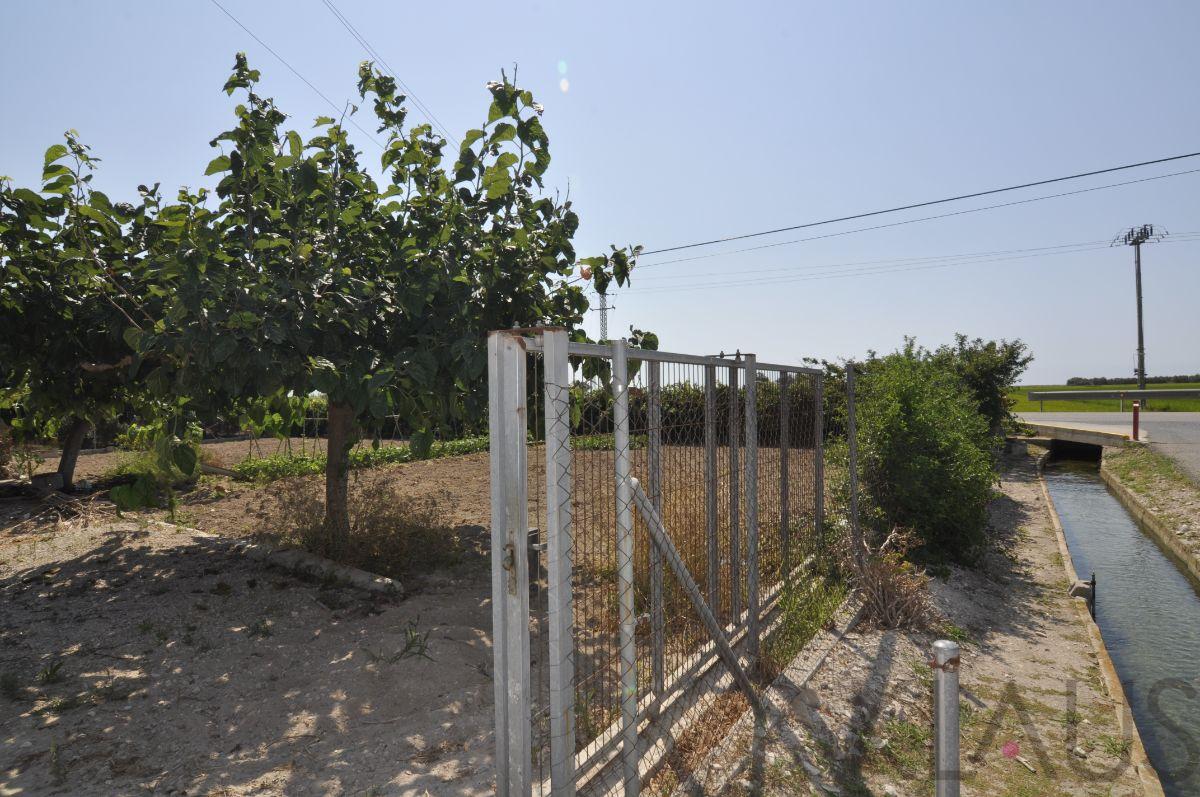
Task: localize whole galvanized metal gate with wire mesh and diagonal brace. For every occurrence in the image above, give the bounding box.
[488,328,824,795]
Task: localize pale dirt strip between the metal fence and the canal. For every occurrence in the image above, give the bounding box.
[684,456,1141,797]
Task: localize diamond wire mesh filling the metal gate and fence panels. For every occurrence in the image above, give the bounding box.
[506,333,838,793]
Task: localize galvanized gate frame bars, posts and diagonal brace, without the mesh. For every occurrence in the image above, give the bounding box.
[487,328,824,797]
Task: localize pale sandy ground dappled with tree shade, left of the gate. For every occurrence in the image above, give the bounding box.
[0,523,493,795]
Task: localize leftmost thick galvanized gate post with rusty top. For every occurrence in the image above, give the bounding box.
[487,331,533,797]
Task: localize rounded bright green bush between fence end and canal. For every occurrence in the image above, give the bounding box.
[857,342,996,559]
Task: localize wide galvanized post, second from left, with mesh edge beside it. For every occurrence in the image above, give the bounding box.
[542,329,575,797]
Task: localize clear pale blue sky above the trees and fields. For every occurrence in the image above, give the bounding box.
[0,0,1200,383]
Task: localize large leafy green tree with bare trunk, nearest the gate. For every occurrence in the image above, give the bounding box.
[128,54,636,552]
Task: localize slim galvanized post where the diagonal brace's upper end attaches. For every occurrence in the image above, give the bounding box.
[612,338,640,797]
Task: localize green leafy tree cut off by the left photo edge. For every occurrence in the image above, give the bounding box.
[0,131,157,489]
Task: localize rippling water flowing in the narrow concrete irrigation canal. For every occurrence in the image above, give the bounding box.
[1045,461,1200,797]
